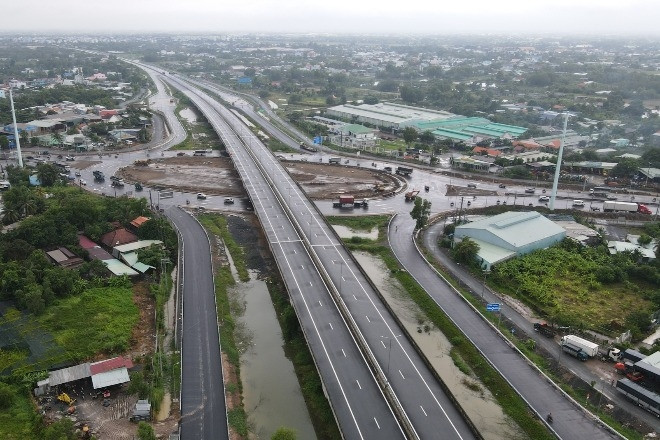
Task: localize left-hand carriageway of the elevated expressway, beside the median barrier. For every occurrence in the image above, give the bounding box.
[166,80,404,439]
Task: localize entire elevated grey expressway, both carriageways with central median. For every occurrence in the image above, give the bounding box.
[161,72,474,439]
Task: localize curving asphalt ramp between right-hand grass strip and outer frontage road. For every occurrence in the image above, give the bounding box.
[388,216,620,439]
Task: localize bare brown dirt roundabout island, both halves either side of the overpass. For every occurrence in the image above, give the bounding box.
[117,157,401,199]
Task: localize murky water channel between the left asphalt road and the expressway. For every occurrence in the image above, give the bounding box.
[232,271,316,439]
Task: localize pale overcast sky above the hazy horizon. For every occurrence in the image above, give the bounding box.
[5,0,660,35]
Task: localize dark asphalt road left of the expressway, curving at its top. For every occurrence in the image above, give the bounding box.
[165,207,229,440]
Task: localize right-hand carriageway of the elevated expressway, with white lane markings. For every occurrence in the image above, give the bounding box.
[168,78,472,438]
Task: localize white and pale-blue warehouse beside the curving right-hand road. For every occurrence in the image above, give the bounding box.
[454,211,566,270]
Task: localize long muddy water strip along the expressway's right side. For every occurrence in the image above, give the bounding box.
[355,252,525,440]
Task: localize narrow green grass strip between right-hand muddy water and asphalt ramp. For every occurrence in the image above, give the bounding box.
[328,215,554,440]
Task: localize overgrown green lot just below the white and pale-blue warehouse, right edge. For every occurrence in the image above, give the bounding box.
[488,240,660,337]
